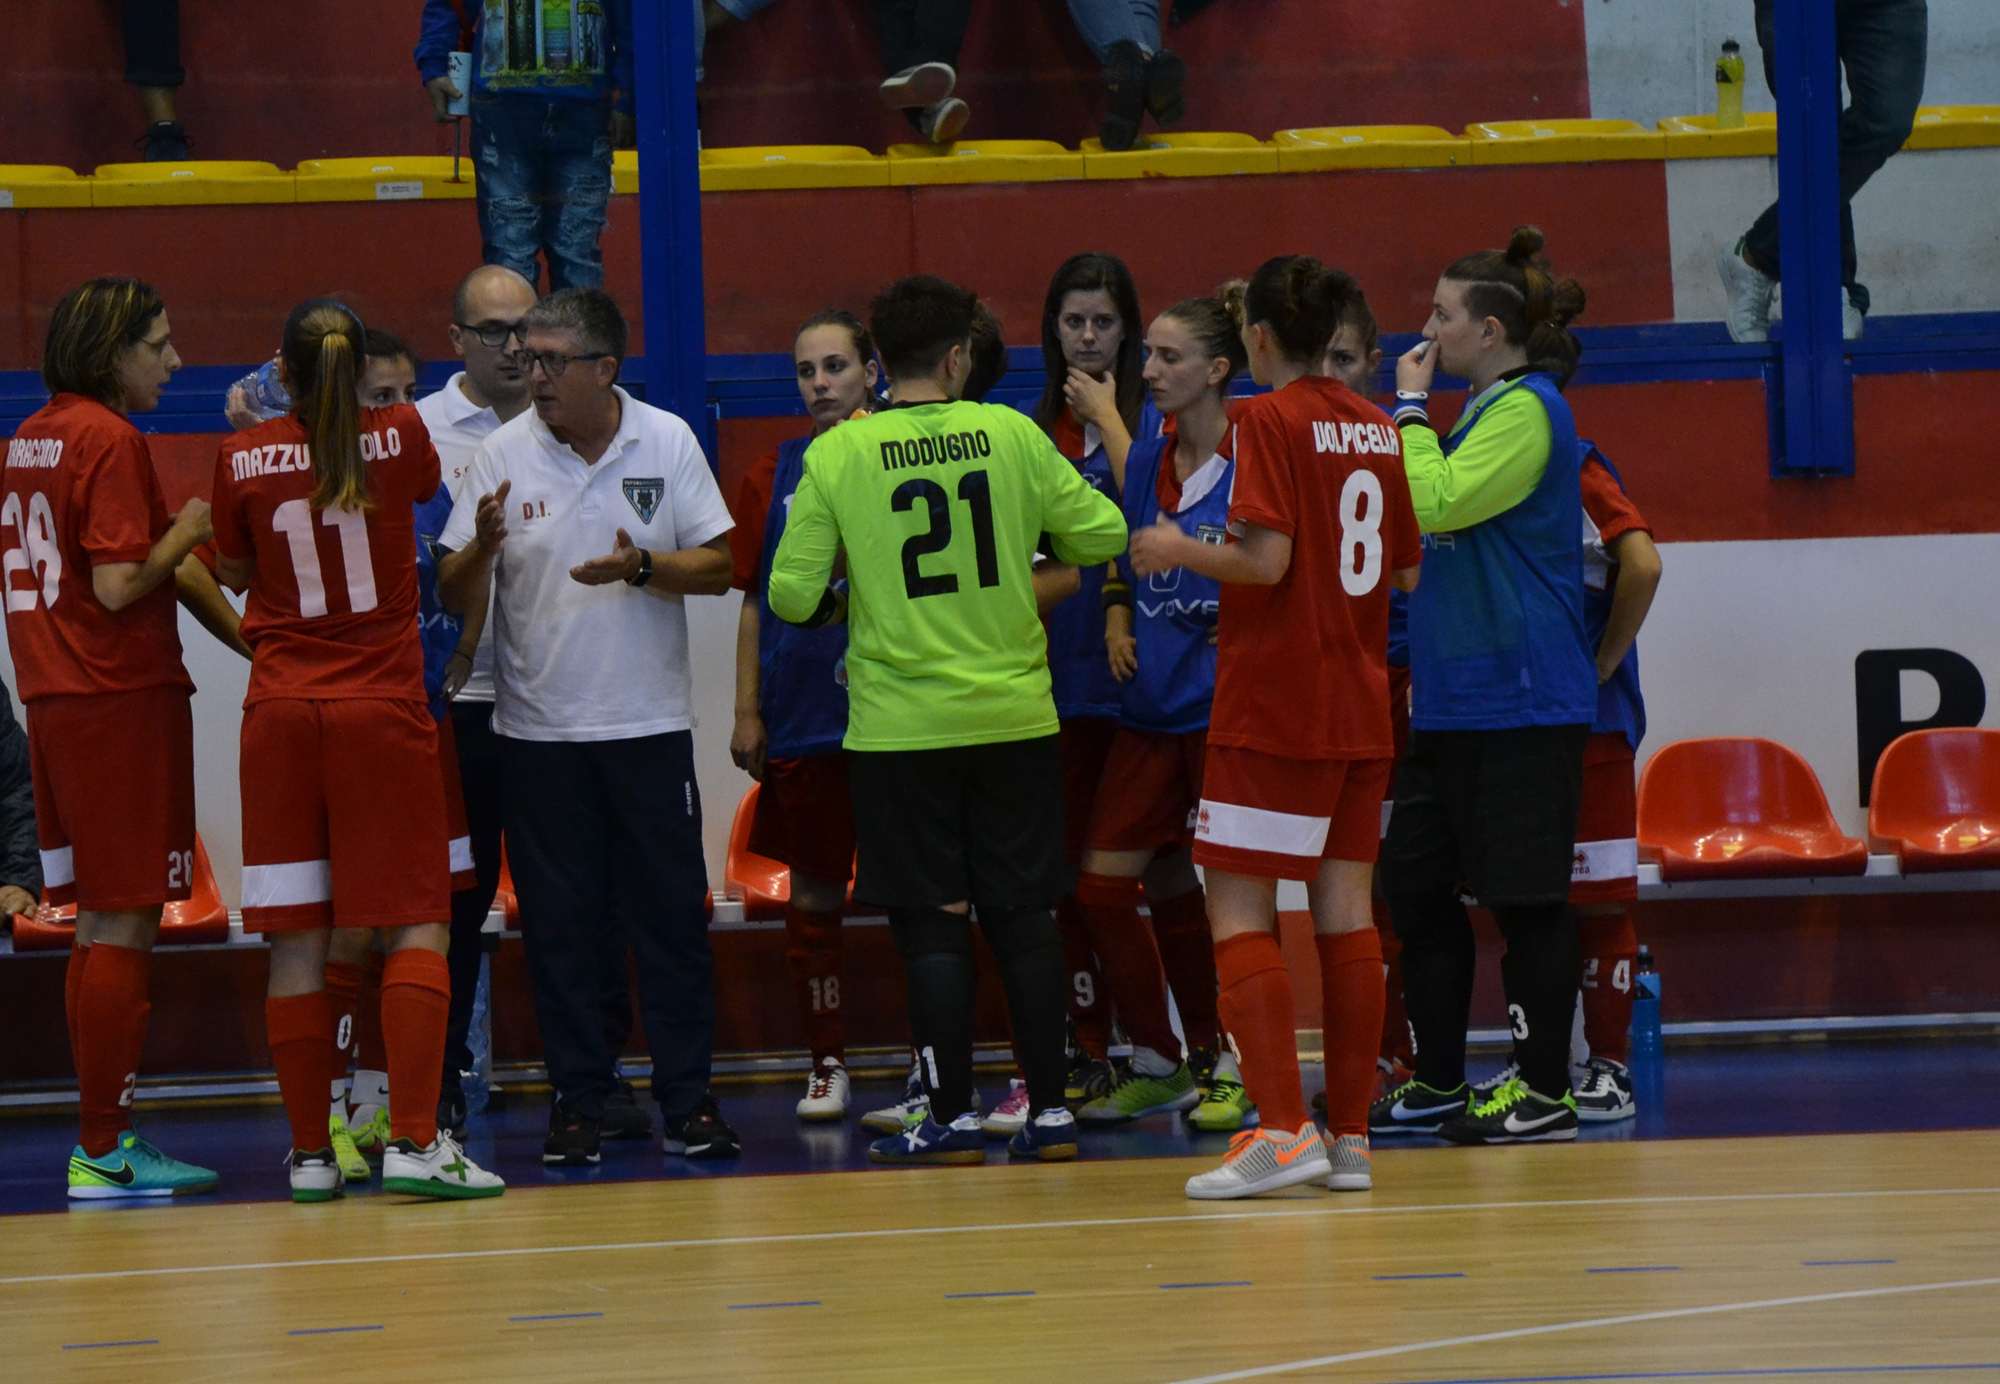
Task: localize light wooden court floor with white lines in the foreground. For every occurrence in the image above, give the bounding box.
[0,1132,2000,1380]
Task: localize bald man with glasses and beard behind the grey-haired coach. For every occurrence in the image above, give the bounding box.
[416,264,540,1130]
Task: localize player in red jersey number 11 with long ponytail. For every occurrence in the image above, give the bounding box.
[214,300,504,1202]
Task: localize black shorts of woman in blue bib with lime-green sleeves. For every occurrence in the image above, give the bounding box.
[1382,726,1590,906]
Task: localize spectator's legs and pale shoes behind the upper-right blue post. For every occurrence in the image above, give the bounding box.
[1716,0,1930,342]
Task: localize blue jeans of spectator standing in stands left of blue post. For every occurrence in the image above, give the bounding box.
[472,94,612,292]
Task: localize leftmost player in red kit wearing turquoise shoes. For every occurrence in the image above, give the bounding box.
[0,278,216,1200]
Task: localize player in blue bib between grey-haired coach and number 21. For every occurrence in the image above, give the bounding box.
[730,310,878,1120]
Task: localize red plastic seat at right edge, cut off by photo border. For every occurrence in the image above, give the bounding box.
[1868,730,2000,874]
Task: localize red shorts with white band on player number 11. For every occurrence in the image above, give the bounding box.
[240,700,452,932]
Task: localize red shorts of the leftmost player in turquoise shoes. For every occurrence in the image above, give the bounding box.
[26,686,194,912]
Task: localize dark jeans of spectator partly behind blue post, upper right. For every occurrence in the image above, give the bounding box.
[1744,0,1930,312]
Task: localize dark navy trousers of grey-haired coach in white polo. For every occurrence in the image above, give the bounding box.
[500,730,716,1120]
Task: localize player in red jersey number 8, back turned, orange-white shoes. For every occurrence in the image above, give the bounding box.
[1132,256,1420,1200]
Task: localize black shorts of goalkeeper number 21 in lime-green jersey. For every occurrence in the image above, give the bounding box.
[848,736,1072,908]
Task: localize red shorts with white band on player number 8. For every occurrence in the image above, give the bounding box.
[1194,746,1394,880]
